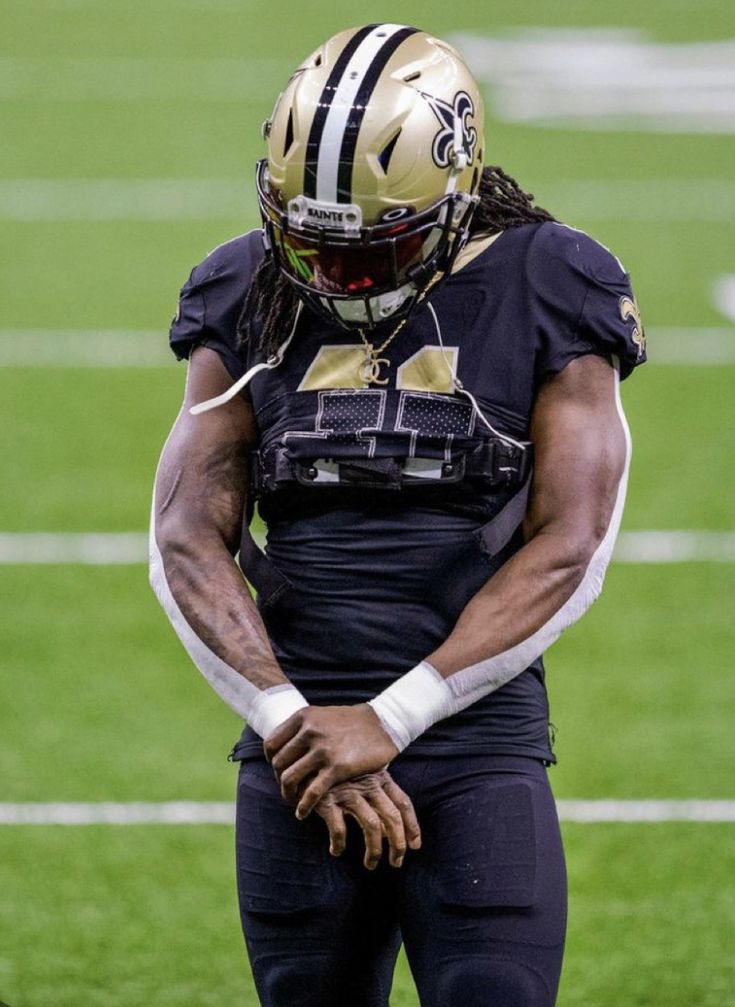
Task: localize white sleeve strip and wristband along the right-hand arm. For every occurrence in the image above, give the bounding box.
[370,377,630,751]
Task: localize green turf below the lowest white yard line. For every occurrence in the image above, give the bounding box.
[0,824,735,1007]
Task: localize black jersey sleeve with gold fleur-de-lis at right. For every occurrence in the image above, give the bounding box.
[531,224,645,381]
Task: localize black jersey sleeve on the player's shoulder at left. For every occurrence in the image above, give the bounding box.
[169,232,262,381]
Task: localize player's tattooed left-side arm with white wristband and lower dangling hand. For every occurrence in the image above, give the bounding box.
[151,347,421,869]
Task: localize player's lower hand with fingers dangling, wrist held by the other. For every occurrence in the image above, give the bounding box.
[314,769,421,871]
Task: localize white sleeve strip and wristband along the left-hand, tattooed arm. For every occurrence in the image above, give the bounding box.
[149,498,308,738]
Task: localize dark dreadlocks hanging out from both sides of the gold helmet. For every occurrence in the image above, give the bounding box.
[238,165,555,355]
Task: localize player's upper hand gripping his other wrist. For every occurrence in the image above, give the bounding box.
[263,703,398,819]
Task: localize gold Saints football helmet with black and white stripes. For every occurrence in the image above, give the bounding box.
[257,24,483,328]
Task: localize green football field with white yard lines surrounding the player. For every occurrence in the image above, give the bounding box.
[0,0,735,1007]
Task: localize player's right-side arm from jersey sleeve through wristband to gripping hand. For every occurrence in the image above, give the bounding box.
[266,355,629,814]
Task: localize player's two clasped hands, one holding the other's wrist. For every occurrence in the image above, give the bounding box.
[263,703,421,870]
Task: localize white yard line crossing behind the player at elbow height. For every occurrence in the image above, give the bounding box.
[0,531,735,566]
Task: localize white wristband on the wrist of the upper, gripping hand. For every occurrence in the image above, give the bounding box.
[370,661,457,751]
